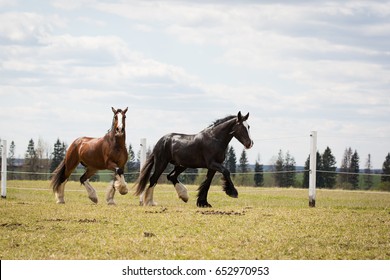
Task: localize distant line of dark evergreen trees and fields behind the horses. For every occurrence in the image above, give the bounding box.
[0,139,390,191]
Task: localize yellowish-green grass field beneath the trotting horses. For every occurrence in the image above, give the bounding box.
[0,181,390,260]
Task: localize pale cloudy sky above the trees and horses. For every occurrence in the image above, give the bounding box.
[0,0,390,168]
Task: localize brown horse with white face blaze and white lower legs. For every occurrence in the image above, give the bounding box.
[51,108,128,204]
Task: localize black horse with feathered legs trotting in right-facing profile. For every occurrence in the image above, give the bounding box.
[135,112,253,207]
